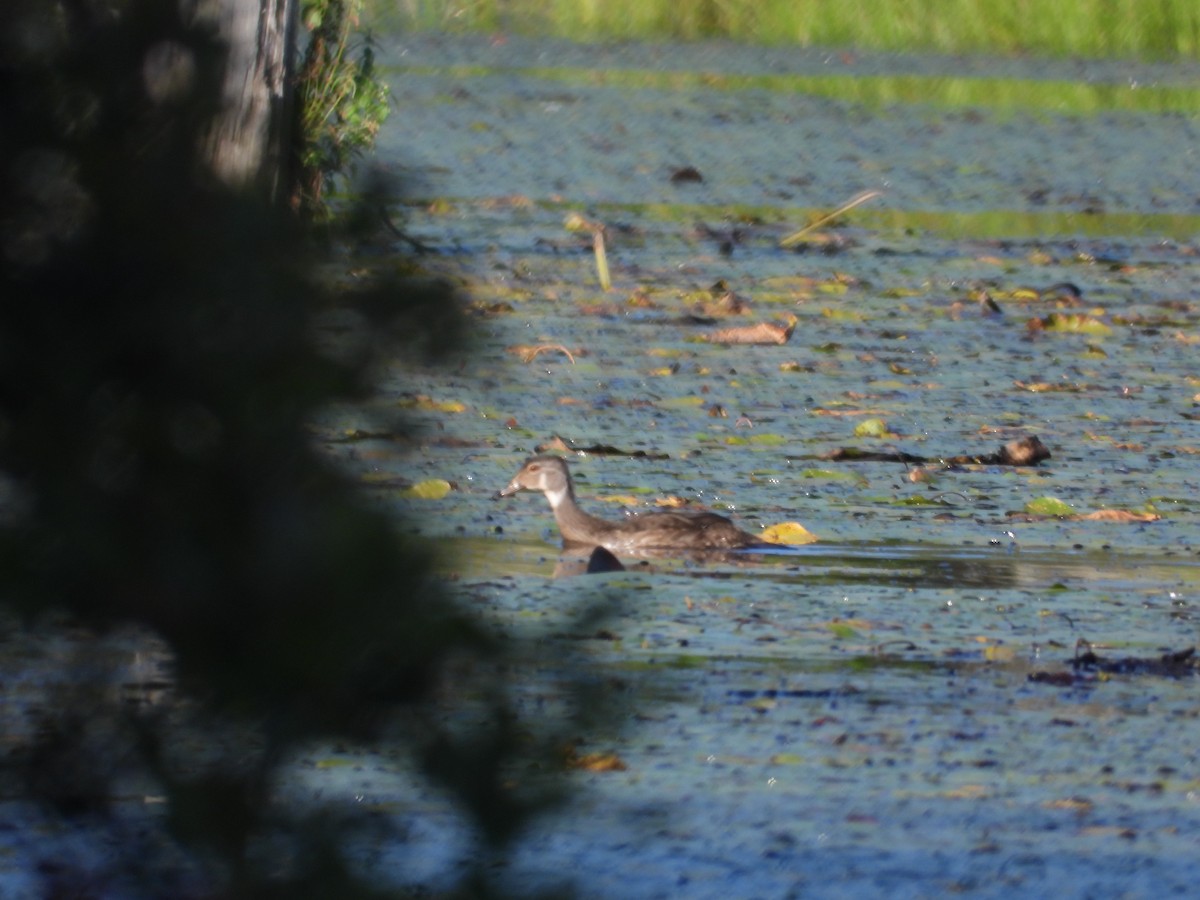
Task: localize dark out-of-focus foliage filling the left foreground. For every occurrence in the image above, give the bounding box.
[0,0,580,898]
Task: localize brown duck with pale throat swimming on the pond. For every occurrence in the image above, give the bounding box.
[496,456,766,553]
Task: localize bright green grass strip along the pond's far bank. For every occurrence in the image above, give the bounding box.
[367,0,1200,59]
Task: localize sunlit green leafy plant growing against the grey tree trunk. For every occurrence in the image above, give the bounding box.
[295,0,390,218]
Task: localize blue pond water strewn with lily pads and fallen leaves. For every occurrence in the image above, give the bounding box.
[294,30,1200,898]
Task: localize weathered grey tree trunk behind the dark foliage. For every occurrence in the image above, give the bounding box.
[194,0,298,203]
